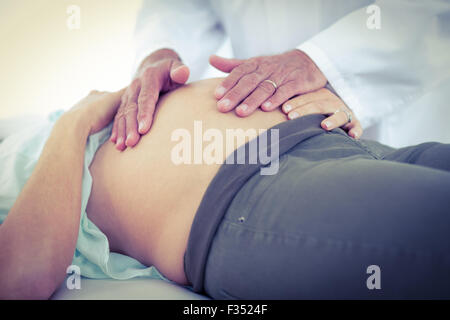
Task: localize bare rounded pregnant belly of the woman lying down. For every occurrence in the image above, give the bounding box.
[87,79,285,284]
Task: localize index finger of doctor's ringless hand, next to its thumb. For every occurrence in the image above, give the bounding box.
[137,69,161,134]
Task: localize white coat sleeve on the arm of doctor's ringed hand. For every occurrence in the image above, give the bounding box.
[297,0,450,127]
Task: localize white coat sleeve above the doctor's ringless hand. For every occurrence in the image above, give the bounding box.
[133,0,225,81]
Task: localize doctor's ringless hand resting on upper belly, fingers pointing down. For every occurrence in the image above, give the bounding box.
[110,49,189,151]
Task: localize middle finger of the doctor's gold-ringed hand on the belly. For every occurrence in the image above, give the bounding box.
[217,72,264,112]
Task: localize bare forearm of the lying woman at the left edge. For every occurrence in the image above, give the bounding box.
[0,115,89,298]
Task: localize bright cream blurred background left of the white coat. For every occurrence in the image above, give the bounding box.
[0,0,141,118]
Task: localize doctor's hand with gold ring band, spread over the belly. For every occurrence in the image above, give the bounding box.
[209,49,327,117]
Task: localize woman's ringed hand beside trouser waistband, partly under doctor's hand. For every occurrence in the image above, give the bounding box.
[281,88,363,139]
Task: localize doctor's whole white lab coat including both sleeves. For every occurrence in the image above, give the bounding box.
[136,0,450,147]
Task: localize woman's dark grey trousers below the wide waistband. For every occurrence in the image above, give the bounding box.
[203,116,450,299]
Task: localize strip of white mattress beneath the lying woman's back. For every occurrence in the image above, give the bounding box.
[51,278,208,300]
